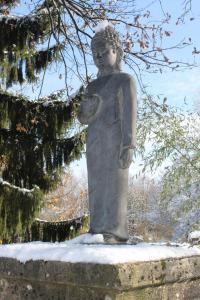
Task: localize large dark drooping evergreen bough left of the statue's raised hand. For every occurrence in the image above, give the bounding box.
[0,93,85,191]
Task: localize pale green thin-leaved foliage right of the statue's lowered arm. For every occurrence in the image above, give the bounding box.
[137,97,200,199]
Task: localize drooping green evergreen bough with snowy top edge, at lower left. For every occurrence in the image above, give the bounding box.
[0,181,43,241]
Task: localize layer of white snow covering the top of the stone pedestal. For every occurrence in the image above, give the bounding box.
[0,234,200,264]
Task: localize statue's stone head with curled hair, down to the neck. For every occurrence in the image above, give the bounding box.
[91,25,123,76]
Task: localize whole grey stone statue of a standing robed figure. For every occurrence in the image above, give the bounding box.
[78,25,137,243]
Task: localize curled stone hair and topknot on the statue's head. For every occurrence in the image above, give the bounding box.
[91,25,123,70]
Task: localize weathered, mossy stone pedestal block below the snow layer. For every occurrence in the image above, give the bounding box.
[0,256,200,300]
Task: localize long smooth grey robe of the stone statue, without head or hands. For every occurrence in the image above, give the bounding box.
[78,73,136,240]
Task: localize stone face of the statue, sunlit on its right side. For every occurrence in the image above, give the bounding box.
[93,43,117,70]
